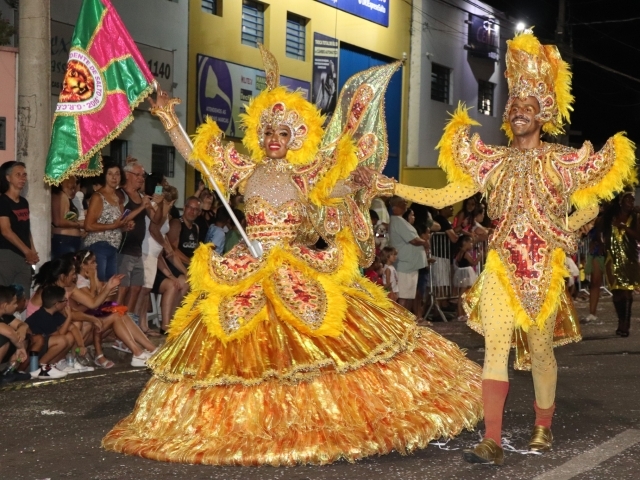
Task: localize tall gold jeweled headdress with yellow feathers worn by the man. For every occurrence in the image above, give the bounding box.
[502,30,573,140]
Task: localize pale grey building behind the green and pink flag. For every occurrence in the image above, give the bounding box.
[0,0,189,204]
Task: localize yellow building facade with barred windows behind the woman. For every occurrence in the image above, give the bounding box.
[187,0,411,189]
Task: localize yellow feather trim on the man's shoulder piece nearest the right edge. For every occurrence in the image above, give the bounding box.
[571,132,638,208]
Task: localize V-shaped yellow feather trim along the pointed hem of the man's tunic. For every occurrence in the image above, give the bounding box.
[485,248,569,332]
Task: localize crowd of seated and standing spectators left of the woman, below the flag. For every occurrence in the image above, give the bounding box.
[0,158,239,383]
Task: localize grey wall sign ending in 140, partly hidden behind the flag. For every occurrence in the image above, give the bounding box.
[51,20,173,110]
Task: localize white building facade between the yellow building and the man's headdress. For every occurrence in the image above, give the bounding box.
[401,0,513,187]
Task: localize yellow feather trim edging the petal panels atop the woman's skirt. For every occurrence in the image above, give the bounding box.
[169,230,391,343]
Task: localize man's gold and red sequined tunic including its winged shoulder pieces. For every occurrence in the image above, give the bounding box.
[454,128,615,324]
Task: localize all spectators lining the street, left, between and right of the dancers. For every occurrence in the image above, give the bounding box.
[0,159,636,382]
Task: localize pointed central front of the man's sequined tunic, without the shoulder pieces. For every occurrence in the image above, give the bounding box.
[489,144,577,318]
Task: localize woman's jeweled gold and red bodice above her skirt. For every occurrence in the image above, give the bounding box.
[244,160,304,247]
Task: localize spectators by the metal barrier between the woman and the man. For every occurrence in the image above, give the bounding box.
[365,191,492,320]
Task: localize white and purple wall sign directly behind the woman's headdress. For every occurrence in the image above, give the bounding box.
[196,54,310,138]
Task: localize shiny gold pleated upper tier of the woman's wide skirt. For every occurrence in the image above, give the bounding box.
[148,296,419,388]
